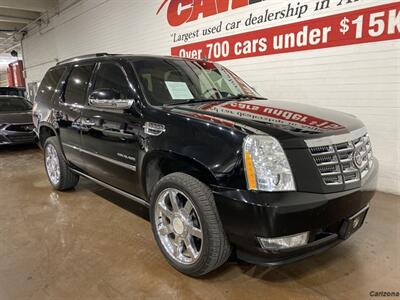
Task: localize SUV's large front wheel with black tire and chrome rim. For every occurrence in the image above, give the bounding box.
[150,173,231,277]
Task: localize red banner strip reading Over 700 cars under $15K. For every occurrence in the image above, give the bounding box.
[171,2,400,61]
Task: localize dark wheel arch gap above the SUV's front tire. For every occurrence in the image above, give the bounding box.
[141,151,217,199]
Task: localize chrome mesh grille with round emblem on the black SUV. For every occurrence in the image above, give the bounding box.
[309,134,373,185]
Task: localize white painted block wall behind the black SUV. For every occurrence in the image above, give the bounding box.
[23,0,400,194]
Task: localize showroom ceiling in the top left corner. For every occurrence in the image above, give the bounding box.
[0,0,57,64]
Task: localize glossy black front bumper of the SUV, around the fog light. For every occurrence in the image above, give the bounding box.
[213,160,379,265]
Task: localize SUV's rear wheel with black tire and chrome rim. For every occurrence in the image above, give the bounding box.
[44,136,79,191]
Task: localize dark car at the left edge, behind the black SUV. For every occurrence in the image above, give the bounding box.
[0,96,36,145]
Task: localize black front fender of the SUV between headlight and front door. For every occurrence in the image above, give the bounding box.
[139,110,246,188]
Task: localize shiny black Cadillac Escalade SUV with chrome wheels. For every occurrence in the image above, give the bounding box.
[33,54,378,276]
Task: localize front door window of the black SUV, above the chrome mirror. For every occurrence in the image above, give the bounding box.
[94,63,130,99]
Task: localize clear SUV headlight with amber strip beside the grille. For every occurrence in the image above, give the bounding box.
[243,135,296,192]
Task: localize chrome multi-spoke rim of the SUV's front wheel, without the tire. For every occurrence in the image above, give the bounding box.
[154,188,203,265]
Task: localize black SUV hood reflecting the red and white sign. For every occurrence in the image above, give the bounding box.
[169,100,364,140]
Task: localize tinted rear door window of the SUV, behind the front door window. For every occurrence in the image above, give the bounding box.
[64,65,93,105]
